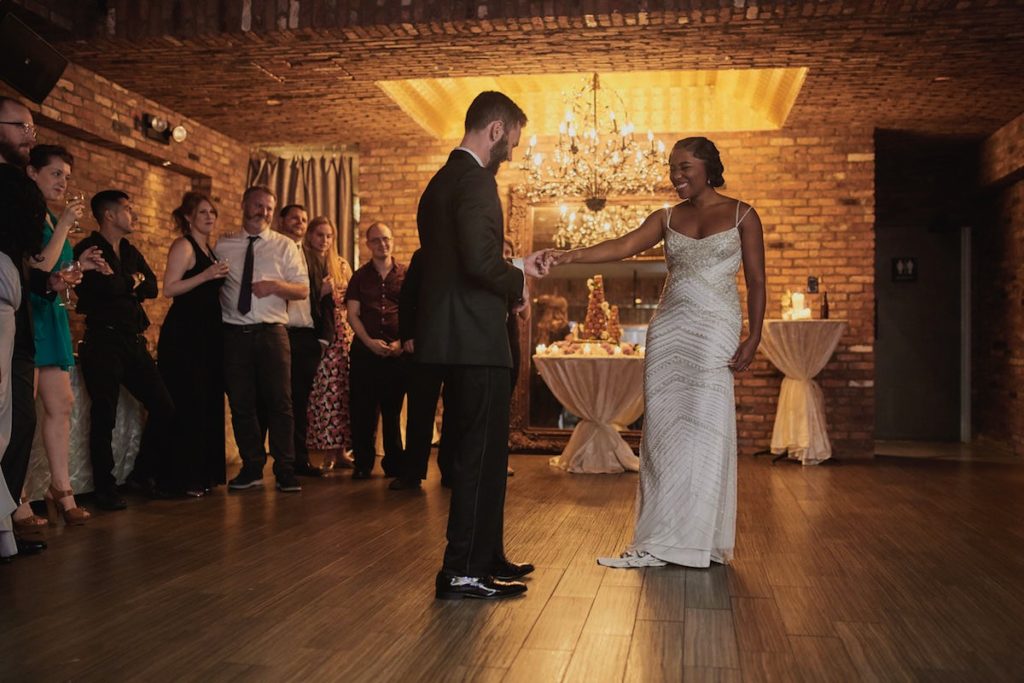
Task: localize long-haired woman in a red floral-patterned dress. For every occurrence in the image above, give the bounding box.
[302,216,352,472]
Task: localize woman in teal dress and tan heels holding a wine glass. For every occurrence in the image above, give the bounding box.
[14,144,109,528]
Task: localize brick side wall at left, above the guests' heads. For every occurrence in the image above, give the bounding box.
[0,65,249,348]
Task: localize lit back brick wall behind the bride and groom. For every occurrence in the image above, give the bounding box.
[359,127,874,458]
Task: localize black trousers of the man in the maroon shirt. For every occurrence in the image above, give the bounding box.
[348,339,408,474]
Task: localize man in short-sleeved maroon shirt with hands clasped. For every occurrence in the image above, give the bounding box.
[345,222,406,479]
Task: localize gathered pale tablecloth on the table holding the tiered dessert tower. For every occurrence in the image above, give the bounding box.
[534,355,643,474]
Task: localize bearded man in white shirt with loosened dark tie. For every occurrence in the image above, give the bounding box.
[217,185,309,492]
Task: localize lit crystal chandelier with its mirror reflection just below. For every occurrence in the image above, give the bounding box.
[518,74,665,247]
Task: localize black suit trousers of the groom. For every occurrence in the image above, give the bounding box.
[443,366,510,577]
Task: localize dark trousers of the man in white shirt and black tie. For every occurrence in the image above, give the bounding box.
[224,324,295,478]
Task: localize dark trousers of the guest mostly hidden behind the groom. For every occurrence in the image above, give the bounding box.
[401,361,452,483]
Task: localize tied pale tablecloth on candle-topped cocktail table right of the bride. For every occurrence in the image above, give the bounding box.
[761,319,846,465]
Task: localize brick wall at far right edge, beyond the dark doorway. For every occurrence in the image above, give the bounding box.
[972,116,1024,455]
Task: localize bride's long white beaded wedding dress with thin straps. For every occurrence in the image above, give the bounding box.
[598,202,750,567]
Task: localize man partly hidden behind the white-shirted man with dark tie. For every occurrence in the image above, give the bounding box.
[278,204,324,477]
